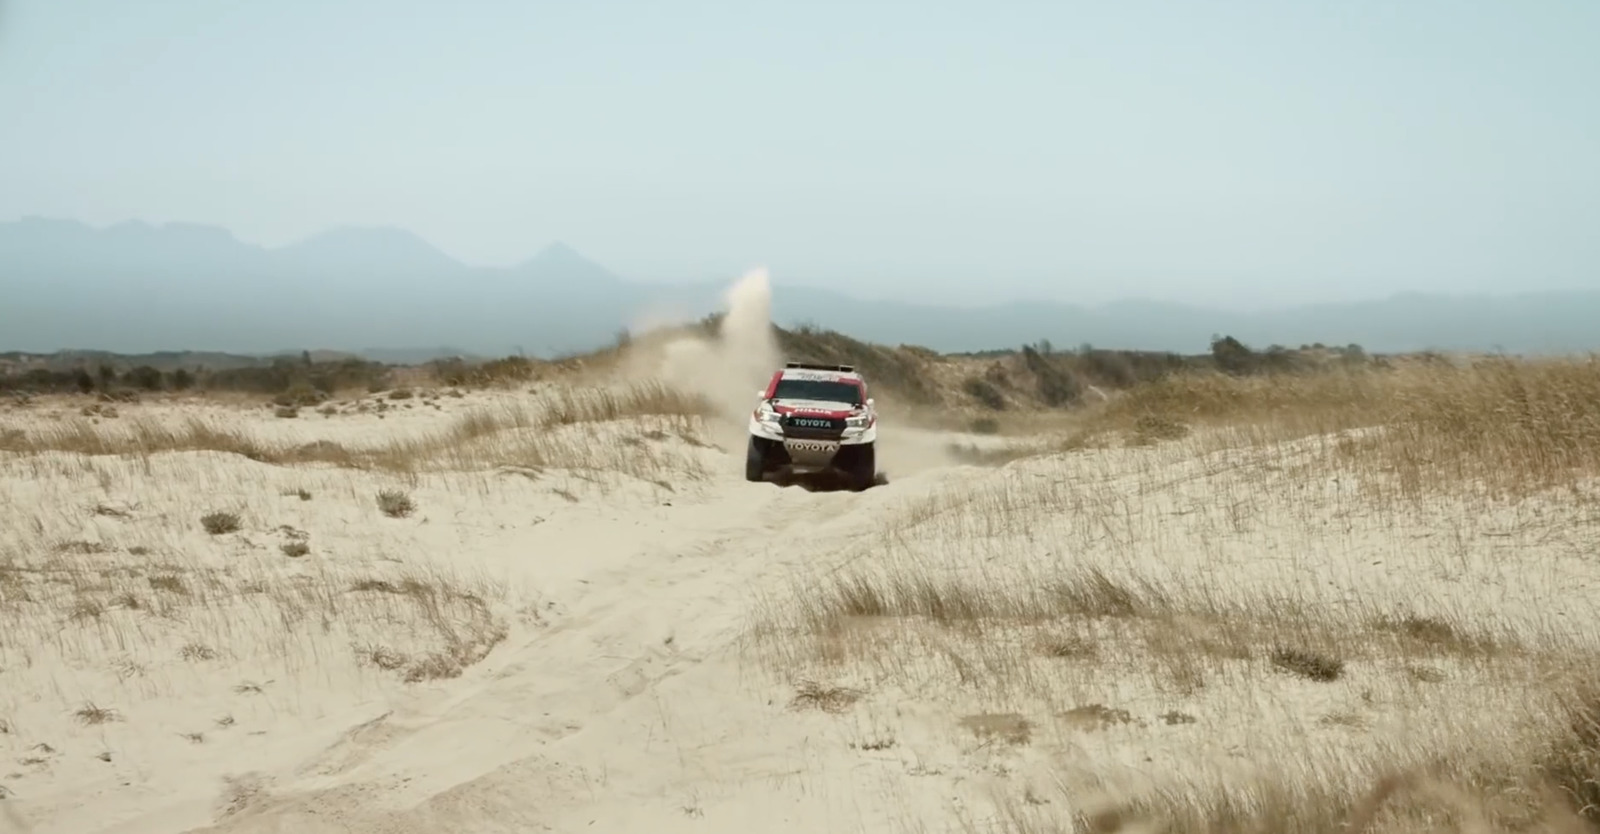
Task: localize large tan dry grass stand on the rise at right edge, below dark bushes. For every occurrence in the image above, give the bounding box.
[1083,357,1600,498]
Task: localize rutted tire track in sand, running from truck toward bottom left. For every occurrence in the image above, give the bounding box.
[175,454,939,834]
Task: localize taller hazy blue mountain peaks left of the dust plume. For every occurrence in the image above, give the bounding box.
[0,218,630,354]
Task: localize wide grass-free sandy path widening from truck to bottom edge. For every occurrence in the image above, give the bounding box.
[62,437,972,834]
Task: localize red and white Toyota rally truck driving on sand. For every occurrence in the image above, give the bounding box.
[744,362,878,491]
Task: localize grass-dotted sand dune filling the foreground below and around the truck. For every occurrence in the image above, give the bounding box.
[9,277,1600,834]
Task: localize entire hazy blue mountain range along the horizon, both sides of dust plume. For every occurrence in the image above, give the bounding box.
[0,218,1600,362]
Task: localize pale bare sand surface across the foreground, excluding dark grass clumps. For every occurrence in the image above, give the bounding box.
[0,384,1600,834]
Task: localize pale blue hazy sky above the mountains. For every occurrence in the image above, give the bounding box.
[0,0,1600,307]
